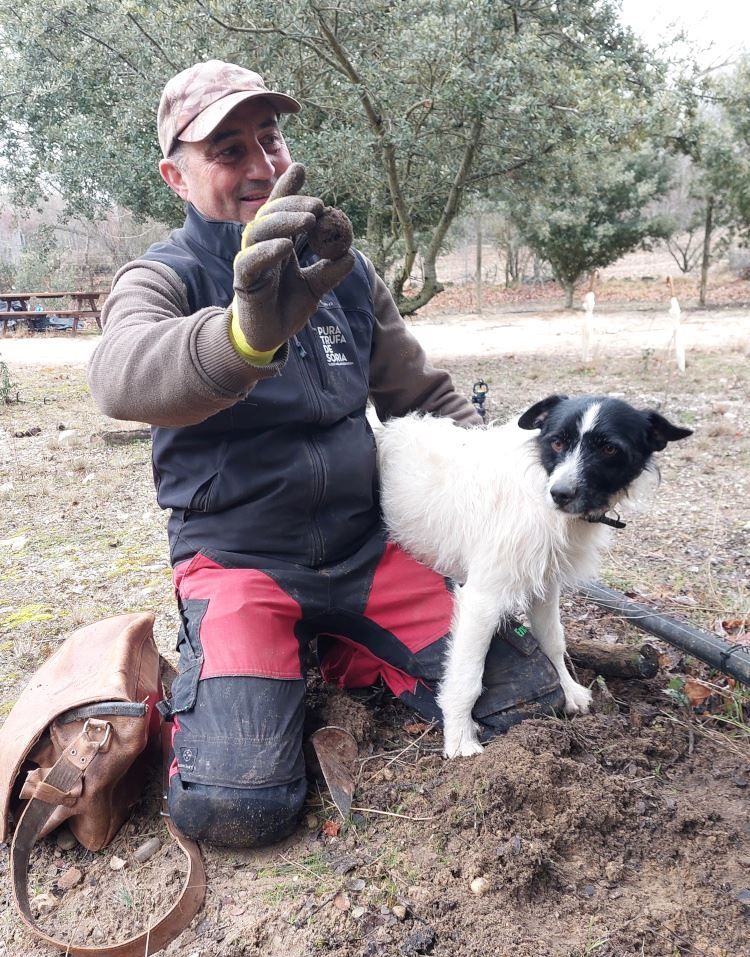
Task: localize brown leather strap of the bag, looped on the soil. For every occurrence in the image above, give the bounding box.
[10,718,206,957]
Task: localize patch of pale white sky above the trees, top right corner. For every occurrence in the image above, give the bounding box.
[622,0,750,66]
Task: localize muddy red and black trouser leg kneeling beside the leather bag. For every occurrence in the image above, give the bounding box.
[168,555,307,847]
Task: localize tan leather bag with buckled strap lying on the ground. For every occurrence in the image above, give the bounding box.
[0,613,206,957]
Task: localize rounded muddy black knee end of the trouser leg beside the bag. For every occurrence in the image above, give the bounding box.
[168,774,307,847]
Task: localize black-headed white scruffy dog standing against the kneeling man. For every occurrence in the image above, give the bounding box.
[375,395,692,757]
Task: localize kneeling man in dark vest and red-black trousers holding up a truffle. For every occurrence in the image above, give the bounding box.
[89,60,562,846]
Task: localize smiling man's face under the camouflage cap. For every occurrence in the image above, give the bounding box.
[159,99,292,224]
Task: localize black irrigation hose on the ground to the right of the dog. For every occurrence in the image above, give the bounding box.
[580,582,750,685]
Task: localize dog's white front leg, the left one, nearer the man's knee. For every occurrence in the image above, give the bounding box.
[437,578,500,758]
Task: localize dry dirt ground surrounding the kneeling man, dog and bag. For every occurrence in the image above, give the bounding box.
[0,296,750,957]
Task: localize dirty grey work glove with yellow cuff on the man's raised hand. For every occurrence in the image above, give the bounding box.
[232,163,354,357]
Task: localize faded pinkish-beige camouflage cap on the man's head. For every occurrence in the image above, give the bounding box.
[157,60,302,156]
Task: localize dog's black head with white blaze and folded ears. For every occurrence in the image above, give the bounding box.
[518,395,693,518]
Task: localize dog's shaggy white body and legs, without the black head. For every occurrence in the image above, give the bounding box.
[375,415,609,757]
